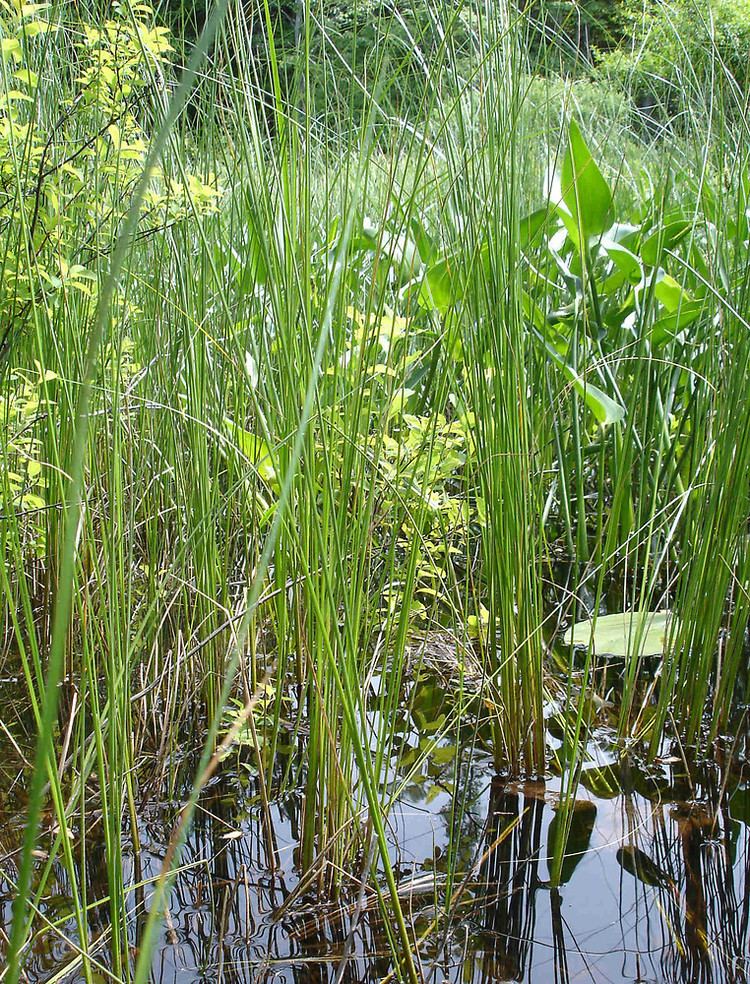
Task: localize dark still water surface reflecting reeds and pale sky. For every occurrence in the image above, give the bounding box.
[0,668,750,984]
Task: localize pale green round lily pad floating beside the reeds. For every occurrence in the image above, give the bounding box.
[564,610,674,656]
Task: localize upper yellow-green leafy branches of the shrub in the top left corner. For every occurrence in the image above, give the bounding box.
[0,0,217,345]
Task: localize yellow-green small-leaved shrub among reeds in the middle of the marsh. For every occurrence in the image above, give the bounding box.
[329,304,476,624]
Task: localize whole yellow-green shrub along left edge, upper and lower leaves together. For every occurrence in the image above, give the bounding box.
[0,0,218,556]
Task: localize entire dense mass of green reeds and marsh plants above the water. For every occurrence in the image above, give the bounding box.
[0,0,750,984]
